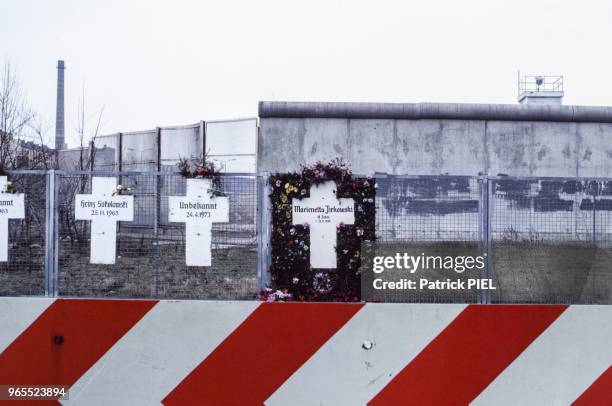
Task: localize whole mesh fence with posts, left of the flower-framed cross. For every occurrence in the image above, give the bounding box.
[0,171,257,299]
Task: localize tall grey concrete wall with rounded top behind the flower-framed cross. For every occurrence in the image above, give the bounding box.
[258,102,612,251]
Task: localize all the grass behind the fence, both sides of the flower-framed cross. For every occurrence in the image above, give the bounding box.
[0,238,612,304]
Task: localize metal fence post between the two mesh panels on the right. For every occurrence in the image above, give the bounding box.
[477,176,493,303]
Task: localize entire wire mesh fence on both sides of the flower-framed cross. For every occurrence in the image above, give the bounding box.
[0,171,612,303]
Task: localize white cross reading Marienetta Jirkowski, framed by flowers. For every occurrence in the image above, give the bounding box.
[292,181,355,268]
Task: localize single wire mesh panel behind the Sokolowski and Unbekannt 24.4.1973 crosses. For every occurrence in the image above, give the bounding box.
[57,173,257,299]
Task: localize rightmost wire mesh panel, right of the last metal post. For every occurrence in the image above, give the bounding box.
[490,178,612,303]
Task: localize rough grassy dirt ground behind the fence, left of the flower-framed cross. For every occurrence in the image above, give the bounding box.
[0,239,257,300]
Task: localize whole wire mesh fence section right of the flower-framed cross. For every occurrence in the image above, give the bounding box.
[376,175,612,303]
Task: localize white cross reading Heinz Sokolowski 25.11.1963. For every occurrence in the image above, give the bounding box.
[74,177,134,264]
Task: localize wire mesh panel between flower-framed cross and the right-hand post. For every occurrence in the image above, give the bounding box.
[376,176,481,302]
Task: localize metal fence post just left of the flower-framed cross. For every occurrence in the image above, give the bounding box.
[257,174,272,290]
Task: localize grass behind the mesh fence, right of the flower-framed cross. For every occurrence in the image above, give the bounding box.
[363,241,612,304]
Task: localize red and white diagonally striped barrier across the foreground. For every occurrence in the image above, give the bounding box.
[0,298,612,406]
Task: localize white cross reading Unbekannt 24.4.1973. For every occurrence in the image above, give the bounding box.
[168,179,229,266]
